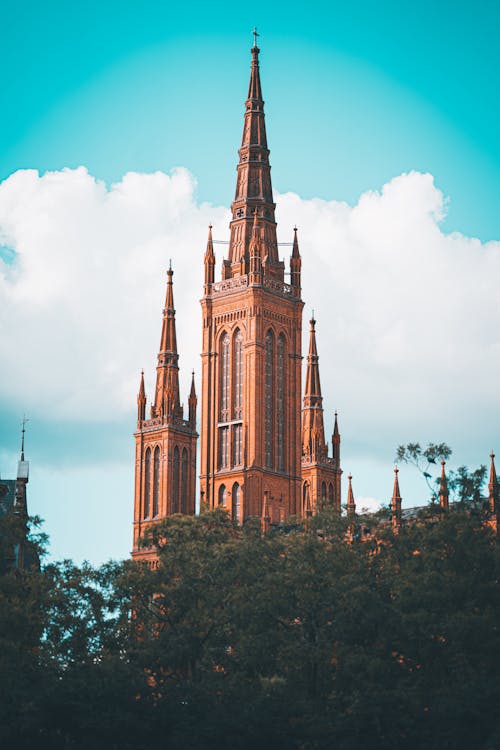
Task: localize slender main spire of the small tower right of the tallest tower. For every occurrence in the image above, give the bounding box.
[302,318,328,463]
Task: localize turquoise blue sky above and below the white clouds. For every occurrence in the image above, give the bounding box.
[0,0,500,559]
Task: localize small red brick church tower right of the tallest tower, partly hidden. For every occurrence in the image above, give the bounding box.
[302,318,342,515]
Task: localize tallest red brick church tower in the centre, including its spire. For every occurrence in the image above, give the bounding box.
[200,41,303,523]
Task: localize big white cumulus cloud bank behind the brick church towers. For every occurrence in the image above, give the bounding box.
[0,167,500,470]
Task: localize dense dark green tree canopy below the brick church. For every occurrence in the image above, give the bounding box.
[0,511,500,750]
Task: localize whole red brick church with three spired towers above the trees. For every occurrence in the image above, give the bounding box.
[133,46,342,557]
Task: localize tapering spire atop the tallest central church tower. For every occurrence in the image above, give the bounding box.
[227,37,284,280]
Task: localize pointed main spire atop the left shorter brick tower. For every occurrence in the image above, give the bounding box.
[151,265,182,422]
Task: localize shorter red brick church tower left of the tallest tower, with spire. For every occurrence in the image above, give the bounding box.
[132,268,198,561]
